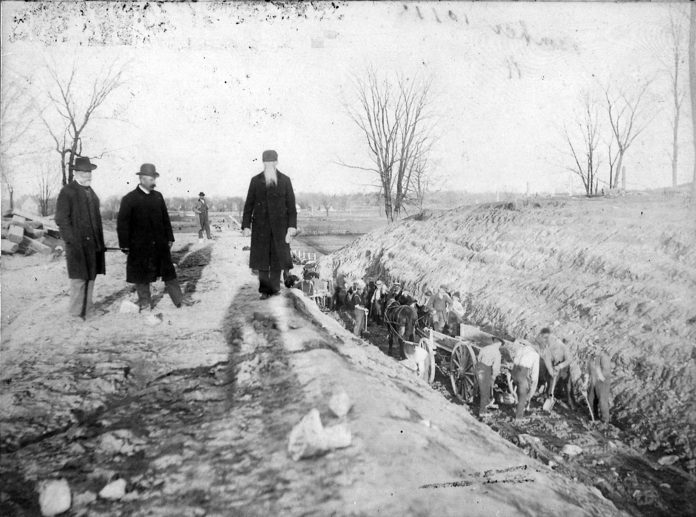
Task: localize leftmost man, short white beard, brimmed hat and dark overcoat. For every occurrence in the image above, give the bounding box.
[56,157,106,319]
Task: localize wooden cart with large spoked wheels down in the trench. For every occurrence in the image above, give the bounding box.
[402,325,508,403]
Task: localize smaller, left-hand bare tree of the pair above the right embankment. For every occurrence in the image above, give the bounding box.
[563,94,600,196]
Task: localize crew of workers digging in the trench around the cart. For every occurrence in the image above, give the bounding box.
[296,268,612,422]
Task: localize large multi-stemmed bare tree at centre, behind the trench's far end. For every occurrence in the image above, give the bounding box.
[341,70,430,222]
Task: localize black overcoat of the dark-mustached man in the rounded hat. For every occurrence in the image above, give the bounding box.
[116,187,176,284]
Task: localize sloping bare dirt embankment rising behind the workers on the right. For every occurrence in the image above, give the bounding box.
[323,189,696,460]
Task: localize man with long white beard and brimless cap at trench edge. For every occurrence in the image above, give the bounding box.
[242,151,297,298]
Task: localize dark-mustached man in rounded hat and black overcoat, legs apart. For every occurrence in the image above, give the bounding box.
[116,163,190,311]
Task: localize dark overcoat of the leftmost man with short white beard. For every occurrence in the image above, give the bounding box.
[56,181,106,280]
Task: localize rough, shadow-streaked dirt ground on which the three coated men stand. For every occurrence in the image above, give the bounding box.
[0,232,621,516]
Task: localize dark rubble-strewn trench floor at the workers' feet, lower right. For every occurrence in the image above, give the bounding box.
[332,312,696,517]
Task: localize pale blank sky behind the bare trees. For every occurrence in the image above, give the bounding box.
[2,2,693,198]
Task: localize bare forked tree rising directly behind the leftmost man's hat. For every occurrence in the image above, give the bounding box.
[42,62,124,185]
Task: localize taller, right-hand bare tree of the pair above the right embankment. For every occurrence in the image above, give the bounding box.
[604,81,654,188]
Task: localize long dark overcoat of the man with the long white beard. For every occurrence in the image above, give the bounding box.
[242,171,297,270]
